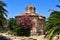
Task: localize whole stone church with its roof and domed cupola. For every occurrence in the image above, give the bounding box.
[16,5,45,35]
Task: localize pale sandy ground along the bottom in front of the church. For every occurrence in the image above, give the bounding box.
[0,33,56,40]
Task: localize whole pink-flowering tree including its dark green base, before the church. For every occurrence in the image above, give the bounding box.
[17,15,34,36]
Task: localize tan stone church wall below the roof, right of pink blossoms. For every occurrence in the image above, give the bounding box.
[31,16,45,35]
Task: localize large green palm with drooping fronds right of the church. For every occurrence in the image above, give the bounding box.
[46,11,60,40]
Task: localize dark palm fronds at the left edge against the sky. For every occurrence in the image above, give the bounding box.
[0,1,8,27]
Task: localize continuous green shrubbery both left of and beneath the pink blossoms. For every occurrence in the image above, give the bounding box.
[8,18,31,36]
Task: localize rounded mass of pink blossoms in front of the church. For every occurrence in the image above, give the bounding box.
[17,15,34,28]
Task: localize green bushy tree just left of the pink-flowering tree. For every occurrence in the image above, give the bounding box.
[7,18,19,35]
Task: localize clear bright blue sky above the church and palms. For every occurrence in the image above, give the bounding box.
[3,0,60,18]
